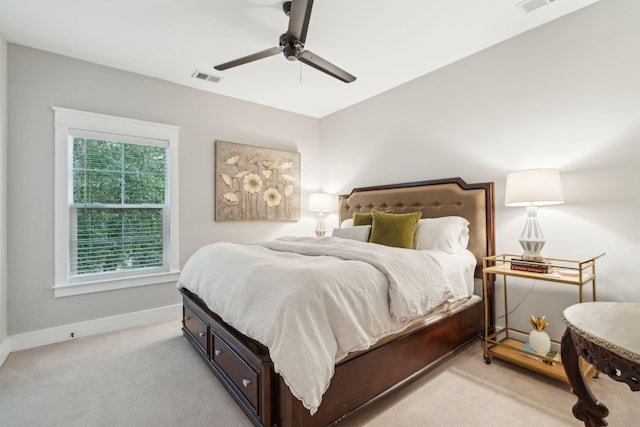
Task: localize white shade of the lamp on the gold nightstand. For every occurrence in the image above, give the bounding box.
[504,169,564,206]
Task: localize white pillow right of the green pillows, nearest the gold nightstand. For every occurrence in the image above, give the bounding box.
[413,216,469,253]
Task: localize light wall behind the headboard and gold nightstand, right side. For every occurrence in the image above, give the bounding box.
[321,0,640,338]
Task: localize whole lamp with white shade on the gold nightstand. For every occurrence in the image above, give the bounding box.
[504,169,564,261]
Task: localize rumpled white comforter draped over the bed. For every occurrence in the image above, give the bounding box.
[178,237,469,414]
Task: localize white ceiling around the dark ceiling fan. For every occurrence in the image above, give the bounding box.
[0,0,598,117]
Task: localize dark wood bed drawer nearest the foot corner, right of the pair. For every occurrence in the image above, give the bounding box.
[212,332,259,412]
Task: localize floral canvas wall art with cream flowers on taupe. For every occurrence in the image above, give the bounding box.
[215,141,300,221]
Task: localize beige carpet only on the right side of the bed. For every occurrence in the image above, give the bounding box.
[341,342,640,427]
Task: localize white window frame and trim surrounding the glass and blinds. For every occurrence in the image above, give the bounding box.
[53,107,180,297]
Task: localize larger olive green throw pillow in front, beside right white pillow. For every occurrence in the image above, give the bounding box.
[368,210,422,249]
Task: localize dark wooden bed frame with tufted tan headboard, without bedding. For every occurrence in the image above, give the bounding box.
[181,178,494,427]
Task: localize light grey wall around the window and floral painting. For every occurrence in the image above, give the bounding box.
[8,43,320,335]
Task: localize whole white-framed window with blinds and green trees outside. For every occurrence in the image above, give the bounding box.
[54,107,179,296]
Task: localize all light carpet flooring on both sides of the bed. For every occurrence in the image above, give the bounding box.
[0,322,640,427]
